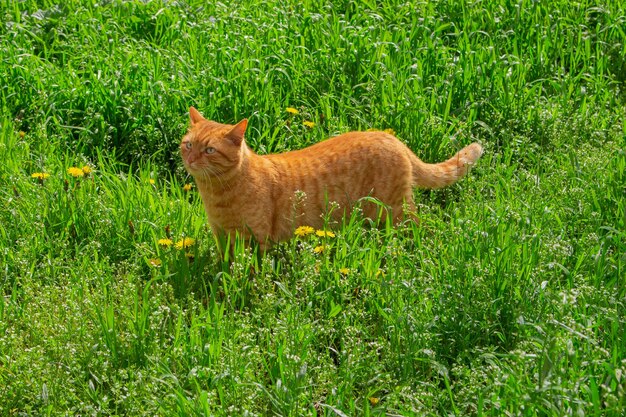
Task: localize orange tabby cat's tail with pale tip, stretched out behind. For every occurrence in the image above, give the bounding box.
[411,143,483,188]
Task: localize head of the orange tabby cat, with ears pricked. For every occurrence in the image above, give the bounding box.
[180,107,248,179]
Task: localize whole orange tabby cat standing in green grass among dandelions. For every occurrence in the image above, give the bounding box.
[180,107,482,249]
